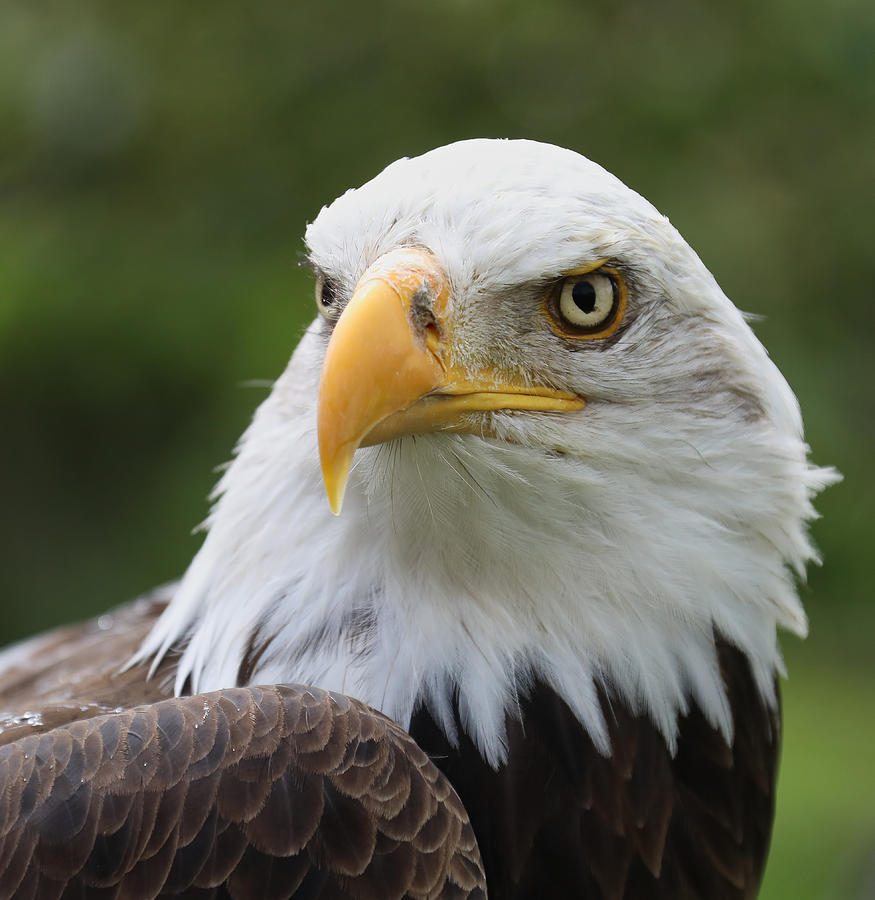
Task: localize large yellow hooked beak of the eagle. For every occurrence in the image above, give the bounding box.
[318,248,585,514]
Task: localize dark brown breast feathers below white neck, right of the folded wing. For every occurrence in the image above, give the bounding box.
[410,644,780,900]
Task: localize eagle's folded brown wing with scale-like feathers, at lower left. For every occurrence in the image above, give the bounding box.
[0,607,485,900]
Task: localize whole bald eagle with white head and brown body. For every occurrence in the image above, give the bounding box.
[0,140,836,900]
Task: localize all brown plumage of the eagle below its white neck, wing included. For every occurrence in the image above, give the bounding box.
[0,599,779,900]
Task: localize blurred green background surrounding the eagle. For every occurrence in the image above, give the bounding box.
[0,0,875,900]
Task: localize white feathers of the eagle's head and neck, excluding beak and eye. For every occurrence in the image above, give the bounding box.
[140,140,836,764]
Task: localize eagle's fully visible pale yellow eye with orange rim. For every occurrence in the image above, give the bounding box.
[547,266,626,339]
